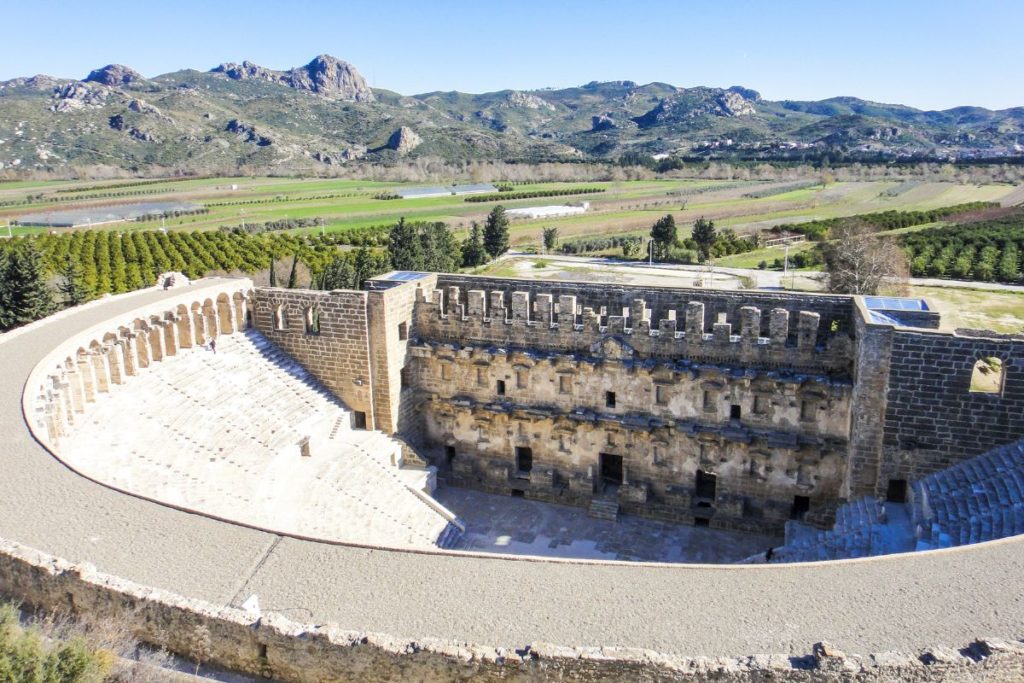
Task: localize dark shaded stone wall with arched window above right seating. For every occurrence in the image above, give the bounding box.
[877,329,1024,494]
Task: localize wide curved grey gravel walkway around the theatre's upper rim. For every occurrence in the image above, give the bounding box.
[0,282,1024,655]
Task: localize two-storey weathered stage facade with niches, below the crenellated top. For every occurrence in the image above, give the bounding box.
[411,343,851,533]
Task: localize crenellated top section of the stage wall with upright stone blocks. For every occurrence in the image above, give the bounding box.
[416,278,852,376]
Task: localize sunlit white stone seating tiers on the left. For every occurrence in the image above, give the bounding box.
[61,331,460,548]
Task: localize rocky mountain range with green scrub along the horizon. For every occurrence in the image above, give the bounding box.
[0,54,1024,173]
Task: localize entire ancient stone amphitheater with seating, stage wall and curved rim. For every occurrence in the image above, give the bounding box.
[0,272,1024,681]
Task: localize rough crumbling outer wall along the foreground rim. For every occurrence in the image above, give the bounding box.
[0,539,1024,683]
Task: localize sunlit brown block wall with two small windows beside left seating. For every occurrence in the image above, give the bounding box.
[253,288,376,429]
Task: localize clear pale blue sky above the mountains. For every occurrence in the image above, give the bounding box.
[8,0,1024,109]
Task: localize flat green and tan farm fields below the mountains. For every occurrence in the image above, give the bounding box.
[0,177,1020,250]
